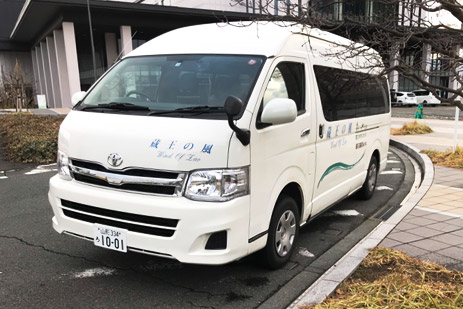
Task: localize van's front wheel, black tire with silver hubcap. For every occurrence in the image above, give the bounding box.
[262,196,300,269]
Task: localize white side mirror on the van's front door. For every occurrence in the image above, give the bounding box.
[260,98,297,124]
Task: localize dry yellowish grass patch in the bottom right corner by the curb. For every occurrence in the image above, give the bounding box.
[302,248,463,309]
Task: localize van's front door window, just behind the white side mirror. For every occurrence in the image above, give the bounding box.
[263,62,305,114]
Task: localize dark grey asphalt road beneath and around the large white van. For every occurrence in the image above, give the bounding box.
[0,150,414,308]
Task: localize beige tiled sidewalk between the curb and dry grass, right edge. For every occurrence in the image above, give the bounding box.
[380,119,463,271]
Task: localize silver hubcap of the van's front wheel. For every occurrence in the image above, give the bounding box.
[275,210,296,257]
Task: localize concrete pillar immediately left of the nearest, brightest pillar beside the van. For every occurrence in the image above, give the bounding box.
[53,30,72,108]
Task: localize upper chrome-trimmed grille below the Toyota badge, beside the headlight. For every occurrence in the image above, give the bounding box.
[69,159,186,196]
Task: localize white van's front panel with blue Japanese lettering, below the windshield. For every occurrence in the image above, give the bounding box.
[59,111,233,171]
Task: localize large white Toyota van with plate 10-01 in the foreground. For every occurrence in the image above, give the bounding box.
[49,23,391,268]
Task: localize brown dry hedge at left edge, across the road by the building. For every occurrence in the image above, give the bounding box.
[0,113,64,163]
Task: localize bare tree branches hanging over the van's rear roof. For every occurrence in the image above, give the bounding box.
[231,0,463,110]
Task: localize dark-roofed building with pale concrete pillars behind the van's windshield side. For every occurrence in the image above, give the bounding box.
[0,0,264,108]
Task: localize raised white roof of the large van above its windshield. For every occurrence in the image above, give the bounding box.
[127,22,351,57]
